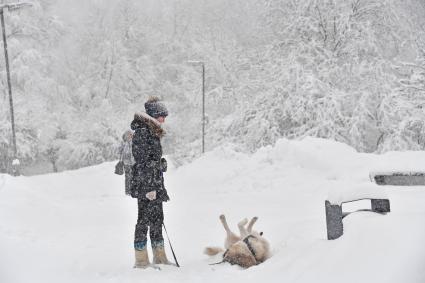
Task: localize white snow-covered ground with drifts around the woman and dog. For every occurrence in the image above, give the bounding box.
[0,138,425,283]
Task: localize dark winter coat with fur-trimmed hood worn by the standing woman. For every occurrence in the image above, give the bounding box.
[130,113,170,202]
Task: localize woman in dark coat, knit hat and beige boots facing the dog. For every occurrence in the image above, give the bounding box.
[131,97,170,268]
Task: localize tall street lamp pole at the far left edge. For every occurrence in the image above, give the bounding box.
[0,3,32,176]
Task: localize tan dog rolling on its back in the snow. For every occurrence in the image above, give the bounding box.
[204,214,270,268]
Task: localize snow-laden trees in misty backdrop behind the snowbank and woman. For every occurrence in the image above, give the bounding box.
[0,0,425,174]
